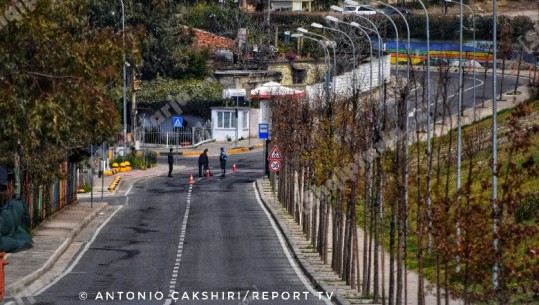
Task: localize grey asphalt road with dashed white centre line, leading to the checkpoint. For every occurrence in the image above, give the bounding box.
[31,151,332,305]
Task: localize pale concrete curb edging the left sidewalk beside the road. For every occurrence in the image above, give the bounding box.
[6,203,108,296]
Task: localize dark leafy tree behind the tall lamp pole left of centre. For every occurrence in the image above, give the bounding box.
[89,0,210,80]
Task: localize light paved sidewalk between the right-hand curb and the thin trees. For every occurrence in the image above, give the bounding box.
[256,178,462,305]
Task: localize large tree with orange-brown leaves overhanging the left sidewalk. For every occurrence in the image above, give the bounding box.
[0,0,122,188]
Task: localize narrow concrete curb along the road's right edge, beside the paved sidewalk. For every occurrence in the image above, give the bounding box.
[256,179,350,305]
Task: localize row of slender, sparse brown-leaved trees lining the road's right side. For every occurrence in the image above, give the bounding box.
[271,48,539,304]
